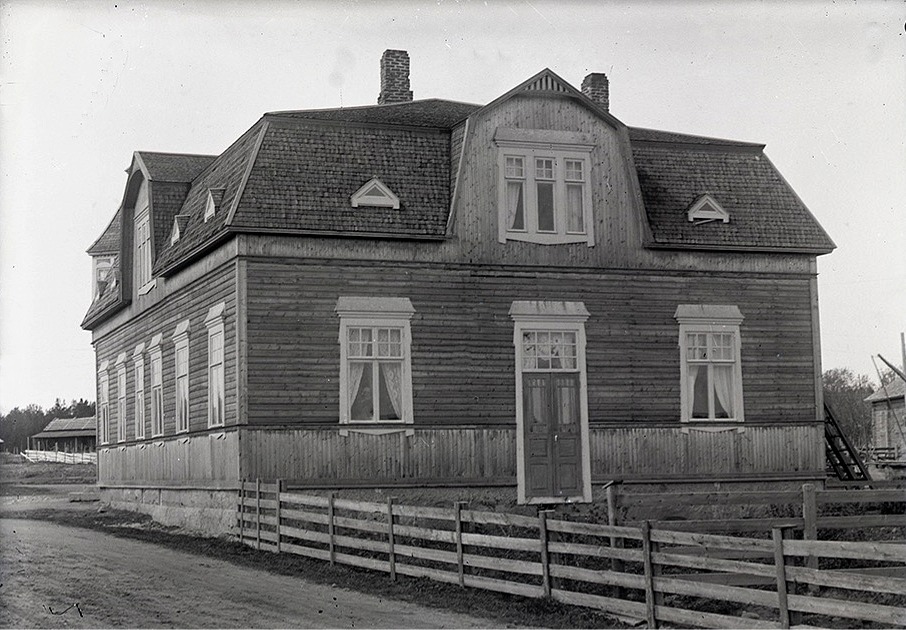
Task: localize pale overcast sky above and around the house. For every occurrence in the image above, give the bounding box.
[0,0,906,412]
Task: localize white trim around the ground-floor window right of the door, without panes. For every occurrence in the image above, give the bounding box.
[674,304,745,430]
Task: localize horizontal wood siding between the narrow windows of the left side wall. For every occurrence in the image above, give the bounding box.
[95,261,237,454]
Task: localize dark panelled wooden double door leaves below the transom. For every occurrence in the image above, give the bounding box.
[522,372,582,499]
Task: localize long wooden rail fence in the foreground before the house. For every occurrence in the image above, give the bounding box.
[238,480,906,628]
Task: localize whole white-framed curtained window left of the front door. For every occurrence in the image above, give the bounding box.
[336,297,415,434]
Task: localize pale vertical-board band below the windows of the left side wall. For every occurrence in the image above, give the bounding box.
[98,430,239,486]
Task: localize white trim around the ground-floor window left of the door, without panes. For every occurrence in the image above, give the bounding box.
[335,296,415,436]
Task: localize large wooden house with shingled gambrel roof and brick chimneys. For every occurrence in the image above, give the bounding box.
[82,50,834,528]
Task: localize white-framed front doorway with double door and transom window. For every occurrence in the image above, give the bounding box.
[510,300,591,503]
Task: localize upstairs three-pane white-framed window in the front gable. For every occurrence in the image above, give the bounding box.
[494,128,595,246]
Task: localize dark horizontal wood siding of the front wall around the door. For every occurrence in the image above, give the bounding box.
[248,259,815,426]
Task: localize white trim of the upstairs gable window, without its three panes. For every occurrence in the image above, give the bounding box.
[494,127,595,247]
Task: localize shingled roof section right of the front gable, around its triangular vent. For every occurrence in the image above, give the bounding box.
[629,129,835,254]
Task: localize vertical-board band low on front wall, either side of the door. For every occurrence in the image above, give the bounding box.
[240,425,824,485]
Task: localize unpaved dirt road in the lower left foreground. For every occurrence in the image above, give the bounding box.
[0,519,495,628]
